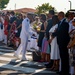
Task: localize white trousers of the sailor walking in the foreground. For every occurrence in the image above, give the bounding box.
[15,37,28,59]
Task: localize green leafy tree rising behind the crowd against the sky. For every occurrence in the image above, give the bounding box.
[36,3,55,14]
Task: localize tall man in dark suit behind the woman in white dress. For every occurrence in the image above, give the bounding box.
[45,10,55,68]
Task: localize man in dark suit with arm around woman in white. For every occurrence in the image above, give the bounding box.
[52,12,70,75]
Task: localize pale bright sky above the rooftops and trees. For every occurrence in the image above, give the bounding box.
[6,0,75,12]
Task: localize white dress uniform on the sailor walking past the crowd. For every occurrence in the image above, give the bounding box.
[15,18,34,60]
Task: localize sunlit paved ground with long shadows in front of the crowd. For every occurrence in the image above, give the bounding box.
[0,43,57,75]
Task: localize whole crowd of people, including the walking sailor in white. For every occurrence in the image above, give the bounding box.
[0,10,75,75]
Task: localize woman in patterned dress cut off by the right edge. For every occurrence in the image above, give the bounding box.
[68,18,75,75]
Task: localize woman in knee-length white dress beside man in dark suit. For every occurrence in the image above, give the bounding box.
[49,15,60,71]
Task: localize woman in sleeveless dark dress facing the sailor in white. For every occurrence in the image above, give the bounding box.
[38,14,47,62]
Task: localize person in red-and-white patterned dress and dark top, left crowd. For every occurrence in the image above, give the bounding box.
[8,11,16,46]
